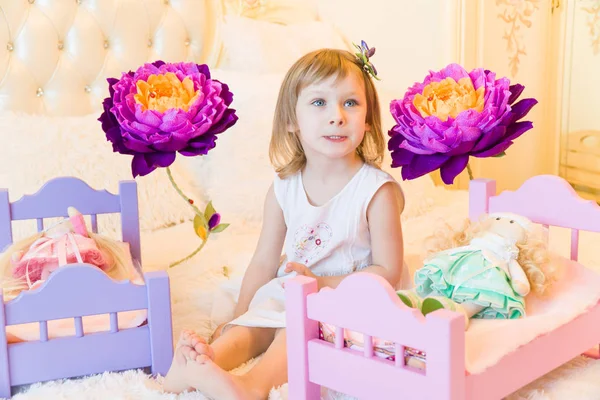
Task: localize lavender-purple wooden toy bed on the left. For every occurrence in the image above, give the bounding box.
[0,177,173,397]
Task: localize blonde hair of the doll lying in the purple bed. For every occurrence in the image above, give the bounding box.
[0,232,130,297]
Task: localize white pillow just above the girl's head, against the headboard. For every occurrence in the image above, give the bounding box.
[219,15,348,73]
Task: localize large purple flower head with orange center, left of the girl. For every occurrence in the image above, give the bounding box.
[99,61,238,177]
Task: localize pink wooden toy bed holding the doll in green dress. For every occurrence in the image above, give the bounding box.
[286,175,600,400]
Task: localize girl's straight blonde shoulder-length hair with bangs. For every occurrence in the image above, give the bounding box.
[269,49,385,178]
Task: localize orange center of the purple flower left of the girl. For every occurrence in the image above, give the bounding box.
[134,72,200,113]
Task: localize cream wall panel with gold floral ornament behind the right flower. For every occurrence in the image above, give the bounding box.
[463,0,561,190]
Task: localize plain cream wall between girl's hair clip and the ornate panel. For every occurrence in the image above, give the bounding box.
[317,0,460,104]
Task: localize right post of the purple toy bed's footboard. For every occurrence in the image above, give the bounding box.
[144,271,173,376]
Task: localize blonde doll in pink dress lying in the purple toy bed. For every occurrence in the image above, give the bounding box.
[0,207,128,297]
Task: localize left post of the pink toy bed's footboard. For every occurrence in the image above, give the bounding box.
[285,276,321,400]
